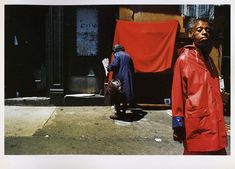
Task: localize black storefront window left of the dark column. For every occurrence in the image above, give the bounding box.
[5,5,48,98]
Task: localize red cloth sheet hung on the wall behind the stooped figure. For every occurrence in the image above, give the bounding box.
[113,20,178,73]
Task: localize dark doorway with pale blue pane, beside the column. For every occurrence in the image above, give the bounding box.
[64,6,117,94]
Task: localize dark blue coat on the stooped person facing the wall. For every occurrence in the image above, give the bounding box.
[108,51,134,102]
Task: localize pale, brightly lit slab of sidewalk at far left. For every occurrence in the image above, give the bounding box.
[4,106,55,137]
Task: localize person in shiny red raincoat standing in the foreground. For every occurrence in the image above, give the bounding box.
[172,18,227,155]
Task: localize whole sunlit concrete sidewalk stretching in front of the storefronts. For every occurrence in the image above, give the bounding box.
[5,106,230,155]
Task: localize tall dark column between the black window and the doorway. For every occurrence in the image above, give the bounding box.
[47,6,64,105]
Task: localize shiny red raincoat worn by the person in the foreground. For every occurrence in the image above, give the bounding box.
[172,45,227,151]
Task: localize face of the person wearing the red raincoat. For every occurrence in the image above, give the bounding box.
[191,21,211,47]
